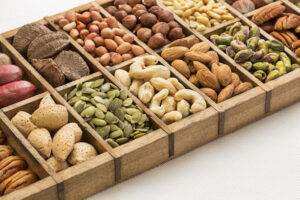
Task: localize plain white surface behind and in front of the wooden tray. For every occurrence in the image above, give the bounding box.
[0,0,300,200]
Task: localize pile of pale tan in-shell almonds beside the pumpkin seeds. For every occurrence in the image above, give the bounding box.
[11,94,97,171]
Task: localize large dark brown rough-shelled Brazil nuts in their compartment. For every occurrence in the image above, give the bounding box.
[12,23,90,87]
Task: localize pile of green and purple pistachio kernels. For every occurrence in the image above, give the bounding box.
[210,22,299,82]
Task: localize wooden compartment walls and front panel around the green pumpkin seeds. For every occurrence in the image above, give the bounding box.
[57,72,169,181]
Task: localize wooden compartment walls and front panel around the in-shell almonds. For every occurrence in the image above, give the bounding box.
[3,92,115,199]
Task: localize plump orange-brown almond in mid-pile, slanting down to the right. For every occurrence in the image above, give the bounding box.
[196,69,221,92]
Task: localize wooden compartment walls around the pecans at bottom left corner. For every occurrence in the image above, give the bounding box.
[0,111,58,200]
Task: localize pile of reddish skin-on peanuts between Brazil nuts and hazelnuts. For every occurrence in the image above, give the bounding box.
[55,7,145,67]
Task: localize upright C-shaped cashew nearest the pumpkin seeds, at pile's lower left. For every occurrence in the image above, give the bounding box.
[149,89,169,118]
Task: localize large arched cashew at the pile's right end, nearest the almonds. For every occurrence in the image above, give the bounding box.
[174,89,206,113]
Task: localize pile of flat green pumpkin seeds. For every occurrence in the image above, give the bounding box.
[65,79,153,147]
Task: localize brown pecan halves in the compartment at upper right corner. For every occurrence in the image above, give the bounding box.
[252,5,300,57]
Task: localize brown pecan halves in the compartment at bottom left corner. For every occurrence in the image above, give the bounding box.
[0,130,38,197]
